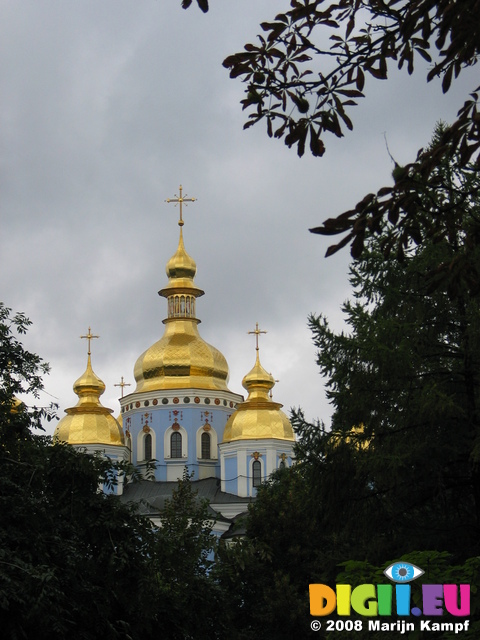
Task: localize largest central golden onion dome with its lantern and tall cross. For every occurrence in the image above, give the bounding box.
[134,187,229,392]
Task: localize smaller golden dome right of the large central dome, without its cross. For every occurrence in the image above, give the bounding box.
[223,348,295,442]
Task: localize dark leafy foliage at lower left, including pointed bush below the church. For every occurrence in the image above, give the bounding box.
[0,304,226,640]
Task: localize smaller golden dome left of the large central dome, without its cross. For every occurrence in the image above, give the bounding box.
[53,353,124,446]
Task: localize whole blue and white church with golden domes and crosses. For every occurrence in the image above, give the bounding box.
[54,187,294,534]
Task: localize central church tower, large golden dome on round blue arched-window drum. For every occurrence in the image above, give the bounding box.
[120,186,243,481]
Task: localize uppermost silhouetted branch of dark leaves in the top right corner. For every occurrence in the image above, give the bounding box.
[219,0,480,155]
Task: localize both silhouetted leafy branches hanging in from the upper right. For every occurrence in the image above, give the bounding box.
[184,0,480,272]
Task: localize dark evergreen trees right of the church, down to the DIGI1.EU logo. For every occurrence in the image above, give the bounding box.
[211,126,480,638]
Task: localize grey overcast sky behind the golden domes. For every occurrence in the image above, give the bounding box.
[0,0,476,436]
